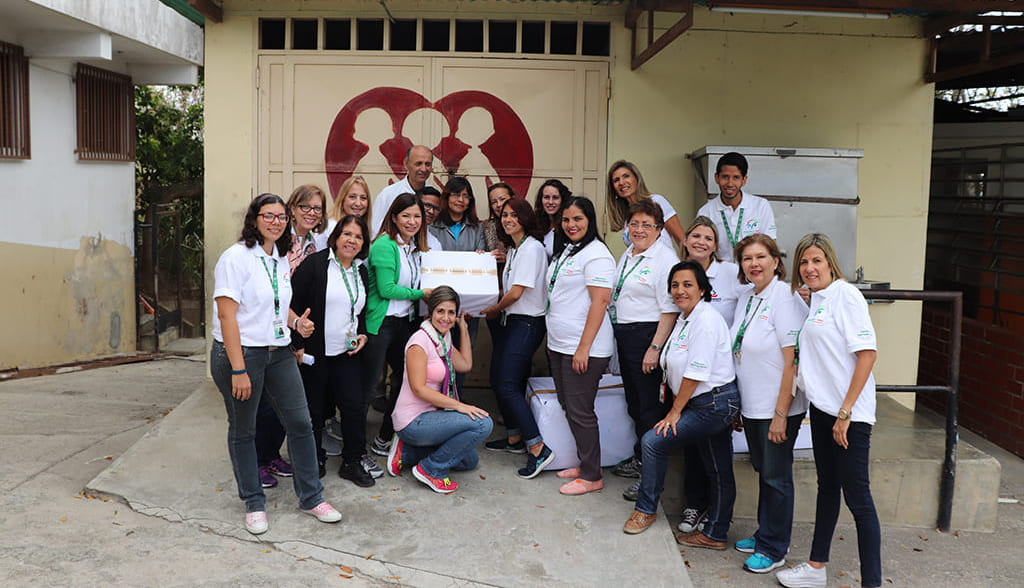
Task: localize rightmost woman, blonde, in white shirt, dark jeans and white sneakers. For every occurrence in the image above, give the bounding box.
[775,234,882,587]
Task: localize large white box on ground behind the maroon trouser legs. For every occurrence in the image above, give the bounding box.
[526,374,637,470]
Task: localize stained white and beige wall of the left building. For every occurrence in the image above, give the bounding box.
[0,61,135,370]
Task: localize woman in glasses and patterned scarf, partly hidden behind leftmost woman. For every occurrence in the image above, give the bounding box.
[256,183,326,488]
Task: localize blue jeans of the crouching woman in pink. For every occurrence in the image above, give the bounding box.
[398,411,494,478]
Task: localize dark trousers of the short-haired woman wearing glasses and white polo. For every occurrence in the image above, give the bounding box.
[614,323,669,459]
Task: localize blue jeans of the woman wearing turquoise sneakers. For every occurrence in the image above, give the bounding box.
[743,415,804,561]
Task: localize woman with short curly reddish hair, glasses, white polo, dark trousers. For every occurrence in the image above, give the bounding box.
[608,198,679,500]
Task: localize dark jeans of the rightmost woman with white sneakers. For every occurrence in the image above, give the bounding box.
[811,405,882,586]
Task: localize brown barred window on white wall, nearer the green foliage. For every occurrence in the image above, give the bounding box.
[75,64,135,161]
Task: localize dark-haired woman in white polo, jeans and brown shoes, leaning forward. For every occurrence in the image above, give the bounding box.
[623,261,739,549]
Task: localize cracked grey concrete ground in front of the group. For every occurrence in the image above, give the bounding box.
[0,356,1024,586]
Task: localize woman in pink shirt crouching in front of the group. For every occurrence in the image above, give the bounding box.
[385,286,494,494]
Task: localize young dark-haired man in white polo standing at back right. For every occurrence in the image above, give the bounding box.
[696,152,776,261]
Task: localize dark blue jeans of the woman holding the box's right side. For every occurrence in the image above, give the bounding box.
[490,314,547,447]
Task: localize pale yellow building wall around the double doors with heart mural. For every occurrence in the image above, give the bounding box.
[206,0,933,401]
